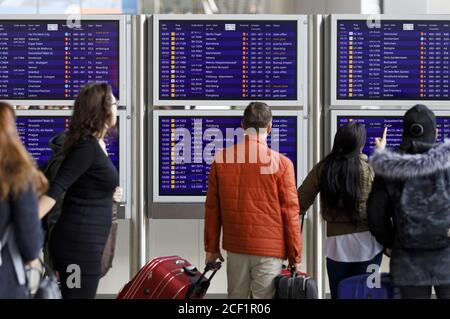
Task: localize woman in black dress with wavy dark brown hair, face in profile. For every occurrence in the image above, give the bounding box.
[40,83,121,299]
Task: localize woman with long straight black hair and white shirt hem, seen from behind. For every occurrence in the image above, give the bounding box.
[298,122,383,299]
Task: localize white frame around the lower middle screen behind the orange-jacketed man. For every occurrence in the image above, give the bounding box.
[152,110,307,203]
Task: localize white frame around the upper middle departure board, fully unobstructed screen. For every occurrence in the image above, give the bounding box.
[153,14,308,107]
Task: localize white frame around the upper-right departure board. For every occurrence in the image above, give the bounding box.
[330,14,450,106]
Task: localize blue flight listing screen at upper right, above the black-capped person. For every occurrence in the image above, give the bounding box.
[335,20,450,100]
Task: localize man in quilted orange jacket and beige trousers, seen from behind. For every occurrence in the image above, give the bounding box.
[204,102,302,299]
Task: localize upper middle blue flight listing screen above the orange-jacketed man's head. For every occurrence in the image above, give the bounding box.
[159,20,298,100]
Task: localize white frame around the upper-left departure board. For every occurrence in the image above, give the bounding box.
[0,14,128,106]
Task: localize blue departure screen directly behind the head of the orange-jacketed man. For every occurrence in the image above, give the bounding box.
[158,116,297,196]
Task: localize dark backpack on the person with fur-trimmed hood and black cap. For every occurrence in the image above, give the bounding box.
[395,170,450,250]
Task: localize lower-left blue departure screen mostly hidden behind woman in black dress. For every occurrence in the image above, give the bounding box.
[16,116,119,172]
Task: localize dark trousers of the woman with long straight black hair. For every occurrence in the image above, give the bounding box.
[327,252,383,299]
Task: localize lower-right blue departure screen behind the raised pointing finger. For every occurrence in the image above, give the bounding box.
[337,116,450,156]
